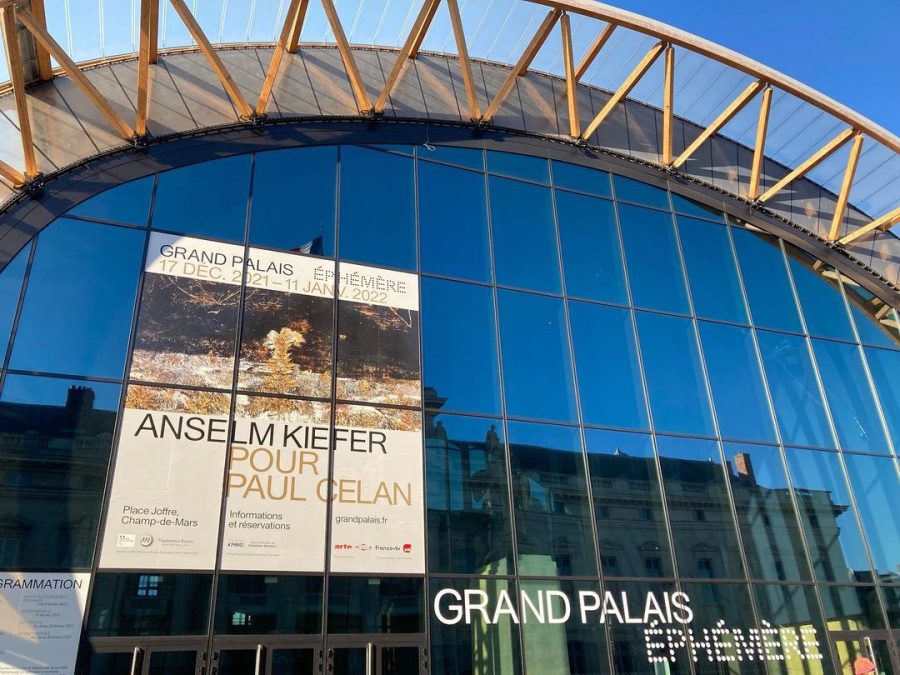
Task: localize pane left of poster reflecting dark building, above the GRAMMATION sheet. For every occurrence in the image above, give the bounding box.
[0,375,120,570]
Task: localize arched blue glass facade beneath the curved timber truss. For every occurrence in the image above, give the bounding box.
[0,145,900,675]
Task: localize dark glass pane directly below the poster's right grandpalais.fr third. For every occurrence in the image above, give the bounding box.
[328,576,425,633]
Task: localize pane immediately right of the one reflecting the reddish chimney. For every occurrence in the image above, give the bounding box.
[786,449,870,581]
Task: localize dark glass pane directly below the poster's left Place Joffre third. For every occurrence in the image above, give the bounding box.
[87,573,212,637]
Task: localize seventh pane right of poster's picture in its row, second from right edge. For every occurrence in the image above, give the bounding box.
[812,340,889,453]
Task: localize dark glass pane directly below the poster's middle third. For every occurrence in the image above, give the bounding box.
[215,574,322,635]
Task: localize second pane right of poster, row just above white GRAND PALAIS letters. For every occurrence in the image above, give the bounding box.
[509,422,597,577]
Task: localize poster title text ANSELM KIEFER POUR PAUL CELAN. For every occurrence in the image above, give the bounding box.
[134,412,413,506]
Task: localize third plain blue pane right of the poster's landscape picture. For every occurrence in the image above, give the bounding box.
[569,302,648,429]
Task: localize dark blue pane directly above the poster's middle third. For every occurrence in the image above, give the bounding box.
[250,147,337,256]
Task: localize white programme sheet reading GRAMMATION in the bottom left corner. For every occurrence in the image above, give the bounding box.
[0,572,91,675]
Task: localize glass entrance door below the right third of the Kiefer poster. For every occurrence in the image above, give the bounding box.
[325,635,428,675]
